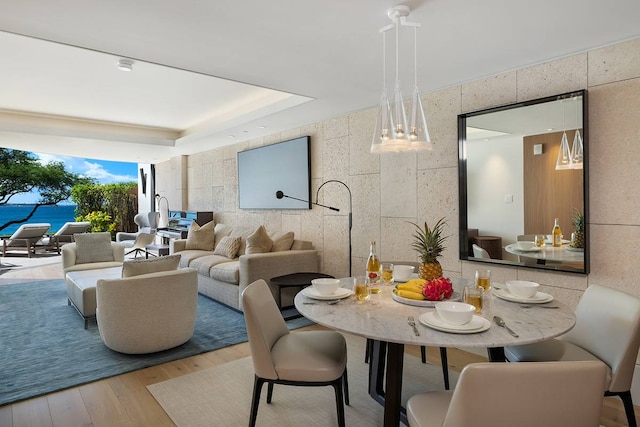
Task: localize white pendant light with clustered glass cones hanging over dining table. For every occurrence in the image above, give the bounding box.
[371,5,433,153]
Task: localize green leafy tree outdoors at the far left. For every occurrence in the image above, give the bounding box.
[0,148,93,231]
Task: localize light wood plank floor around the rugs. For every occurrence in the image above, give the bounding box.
[0,258,640,427]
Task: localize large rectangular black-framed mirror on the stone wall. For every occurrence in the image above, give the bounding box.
[458,90,589,274]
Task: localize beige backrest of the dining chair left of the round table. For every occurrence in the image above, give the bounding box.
[242,280,289,380]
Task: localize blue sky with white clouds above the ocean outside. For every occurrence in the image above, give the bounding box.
[10,153,138,203]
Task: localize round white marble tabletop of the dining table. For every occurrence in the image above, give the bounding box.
[295,280,575,348]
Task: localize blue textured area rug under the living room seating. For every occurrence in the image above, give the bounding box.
[0,280,311,405]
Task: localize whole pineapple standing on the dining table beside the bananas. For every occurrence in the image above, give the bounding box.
[411,218,446,280]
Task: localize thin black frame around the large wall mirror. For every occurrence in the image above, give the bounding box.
[458,90,591,274]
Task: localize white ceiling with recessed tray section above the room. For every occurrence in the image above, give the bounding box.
[0,0,640,163]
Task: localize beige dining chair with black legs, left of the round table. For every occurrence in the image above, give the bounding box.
[242,279,349,426]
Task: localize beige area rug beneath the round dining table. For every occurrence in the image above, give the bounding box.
[147,334,458,427]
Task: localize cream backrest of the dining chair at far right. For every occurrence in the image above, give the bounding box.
[560,285,640,392]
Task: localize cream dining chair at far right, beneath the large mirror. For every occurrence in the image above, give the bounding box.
[505,285,640,426]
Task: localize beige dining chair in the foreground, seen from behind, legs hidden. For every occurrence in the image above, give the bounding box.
[407,361,607,427]
